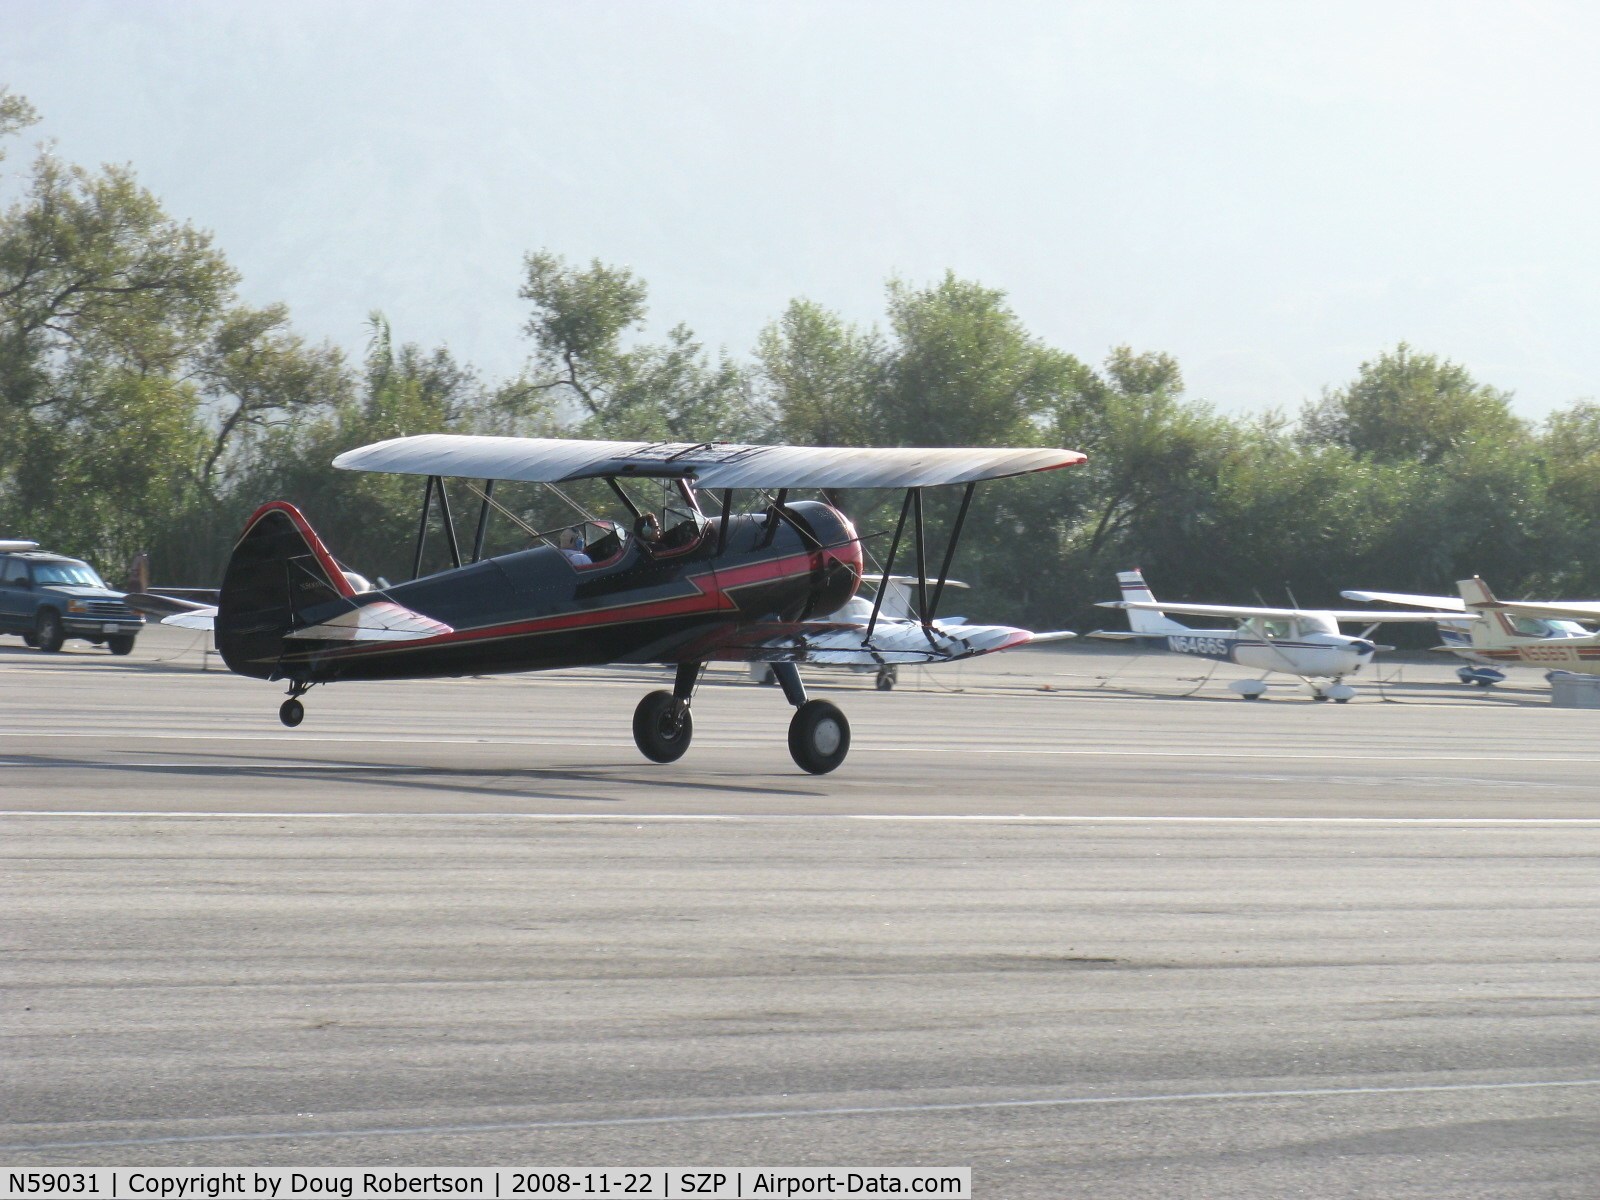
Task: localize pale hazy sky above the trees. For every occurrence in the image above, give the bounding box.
[0,0,1600,416]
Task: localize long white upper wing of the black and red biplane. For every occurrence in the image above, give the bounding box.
[333,434,1085,488]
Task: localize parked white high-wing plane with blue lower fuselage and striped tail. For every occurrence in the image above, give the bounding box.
[1090,570,1459,704]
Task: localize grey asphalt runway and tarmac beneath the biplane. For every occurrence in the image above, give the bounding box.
[0,629,1600,1200]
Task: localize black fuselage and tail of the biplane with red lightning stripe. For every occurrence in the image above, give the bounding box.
[218,501,862,683]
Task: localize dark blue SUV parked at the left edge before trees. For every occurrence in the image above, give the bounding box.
[0,541,144,654]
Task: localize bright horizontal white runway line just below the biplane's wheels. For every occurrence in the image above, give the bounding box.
[9,808,1600,826]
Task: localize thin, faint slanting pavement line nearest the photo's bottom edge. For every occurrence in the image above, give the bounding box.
[0,1078,1600,1150]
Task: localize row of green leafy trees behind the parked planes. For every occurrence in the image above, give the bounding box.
[0,91,1600,627]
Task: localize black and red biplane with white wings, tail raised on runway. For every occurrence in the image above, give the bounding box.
[181,434,1083,774]
